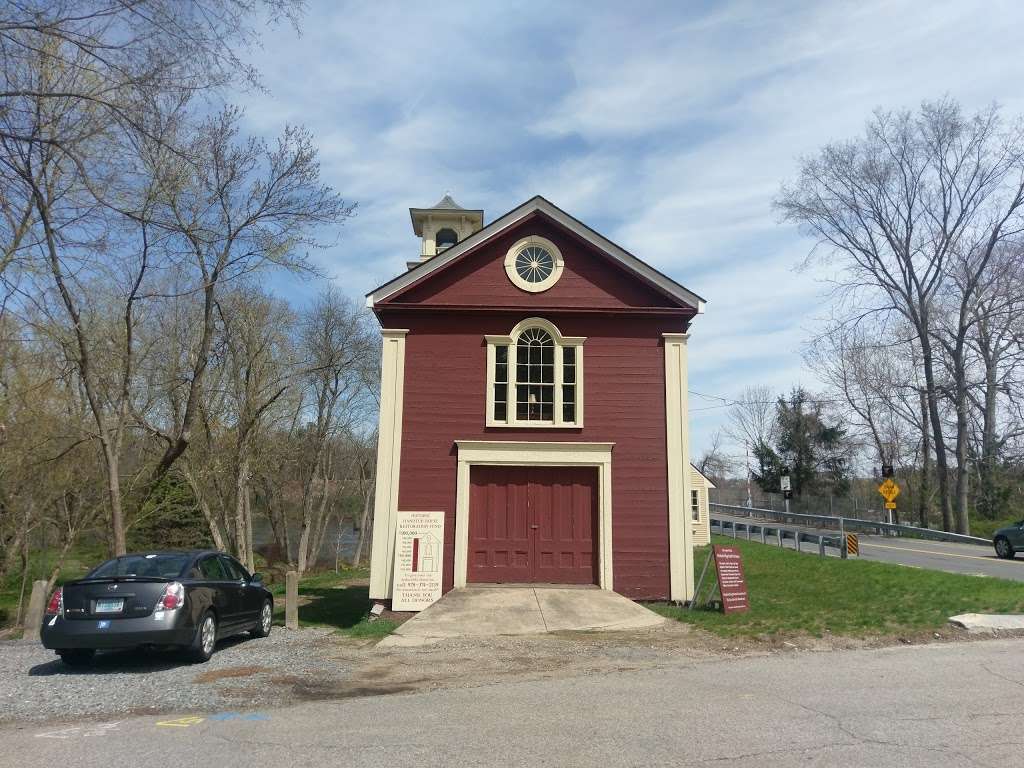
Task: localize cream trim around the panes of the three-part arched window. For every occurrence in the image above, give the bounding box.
[483,317,587,429]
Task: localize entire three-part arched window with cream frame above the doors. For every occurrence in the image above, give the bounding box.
[486,317,585,427]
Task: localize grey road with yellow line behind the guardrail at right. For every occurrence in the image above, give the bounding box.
[713,512,1024,582]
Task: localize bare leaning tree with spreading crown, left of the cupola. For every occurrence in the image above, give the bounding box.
[142,109,353,518]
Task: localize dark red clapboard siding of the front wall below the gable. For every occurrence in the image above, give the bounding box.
[379,311,683,599]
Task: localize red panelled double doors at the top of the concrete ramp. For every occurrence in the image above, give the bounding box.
[466,466,597,584]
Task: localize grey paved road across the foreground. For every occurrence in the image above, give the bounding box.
[0,640,1024,768]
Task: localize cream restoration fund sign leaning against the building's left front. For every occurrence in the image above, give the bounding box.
[391,510,444,610]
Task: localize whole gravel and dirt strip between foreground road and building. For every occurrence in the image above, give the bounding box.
[6,623,975,729]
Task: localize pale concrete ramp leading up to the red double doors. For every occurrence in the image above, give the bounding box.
[379,585,666,647]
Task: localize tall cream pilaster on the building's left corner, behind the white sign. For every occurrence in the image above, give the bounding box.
[370,329,409,600]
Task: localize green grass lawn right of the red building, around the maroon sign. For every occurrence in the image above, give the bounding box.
[649,537,1024,637]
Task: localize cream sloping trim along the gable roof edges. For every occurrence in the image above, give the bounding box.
[367,196,705,313]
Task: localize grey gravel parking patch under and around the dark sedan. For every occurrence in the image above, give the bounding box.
[0,628,351,722]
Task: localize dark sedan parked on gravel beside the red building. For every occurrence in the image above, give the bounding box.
[42,551,273,666]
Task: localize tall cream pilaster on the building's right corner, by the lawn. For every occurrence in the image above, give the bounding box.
[662,334,693,602]
